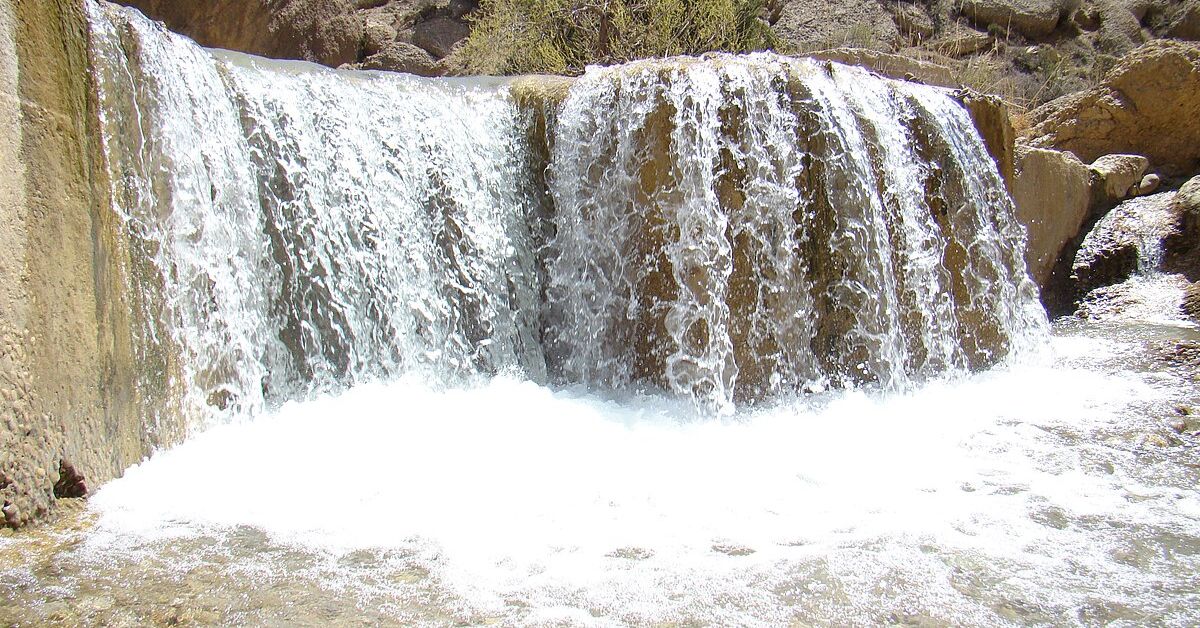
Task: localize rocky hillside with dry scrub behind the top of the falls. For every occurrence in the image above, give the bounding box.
[122,0,1200,107]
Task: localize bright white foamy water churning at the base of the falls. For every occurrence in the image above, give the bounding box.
[82,337,1200,623]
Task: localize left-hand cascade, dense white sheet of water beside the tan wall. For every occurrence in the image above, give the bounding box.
[91,5,545,427]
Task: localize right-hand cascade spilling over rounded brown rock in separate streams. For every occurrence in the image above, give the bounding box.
[546,55,1044,409]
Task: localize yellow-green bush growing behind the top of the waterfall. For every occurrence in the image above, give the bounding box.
[455,0,778,74]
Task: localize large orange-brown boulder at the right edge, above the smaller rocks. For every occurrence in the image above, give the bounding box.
[1026,40,1200,175]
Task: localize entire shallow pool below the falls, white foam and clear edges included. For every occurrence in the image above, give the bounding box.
[0,277,1200,626]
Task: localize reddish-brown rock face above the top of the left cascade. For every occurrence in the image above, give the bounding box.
[120,0,364,67]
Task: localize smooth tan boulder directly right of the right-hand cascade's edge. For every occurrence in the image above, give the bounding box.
[1013,148,1091,287]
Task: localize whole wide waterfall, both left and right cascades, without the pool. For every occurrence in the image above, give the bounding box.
[89,2,1045,425]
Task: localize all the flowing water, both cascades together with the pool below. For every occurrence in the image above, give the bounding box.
[0,4,1200,626]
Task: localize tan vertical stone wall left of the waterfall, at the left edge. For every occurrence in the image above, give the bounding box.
[0,0,178,527]
